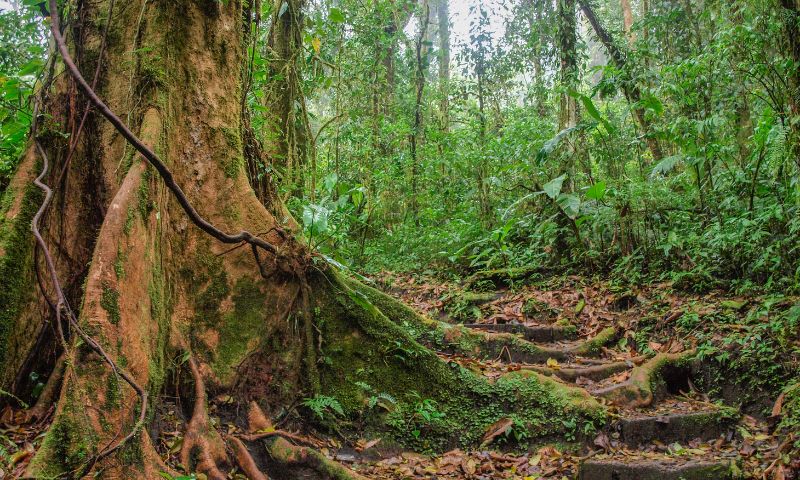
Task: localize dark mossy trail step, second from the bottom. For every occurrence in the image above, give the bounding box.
[613,409,736,448]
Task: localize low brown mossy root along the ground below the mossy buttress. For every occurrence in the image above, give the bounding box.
[248,402,367,480]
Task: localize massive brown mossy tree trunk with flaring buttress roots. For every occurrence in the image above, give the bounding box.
[0,0,603,479]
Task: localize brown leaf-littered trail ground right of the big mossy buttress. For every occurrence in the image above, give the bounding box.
[340,273,800,480]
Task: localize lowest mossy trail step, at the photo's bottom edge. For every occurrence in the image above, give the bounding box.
[578,455,736,480]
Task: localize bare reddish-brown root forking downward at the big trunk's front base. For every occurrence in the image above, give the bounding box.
[180,357,228,480]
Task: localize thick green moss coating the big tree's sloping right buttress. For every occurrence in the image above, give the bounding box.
[312,272,605,451]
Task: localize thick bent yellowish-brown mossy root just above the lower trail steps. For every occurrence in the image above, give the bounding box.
[593,351,694,408]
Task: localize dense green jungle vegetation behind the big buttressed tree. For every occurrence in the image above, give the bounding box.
[0,0,800,291]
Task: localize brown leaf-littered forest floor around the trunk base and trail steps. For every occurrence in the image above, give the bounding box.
[0,273,800,480]
